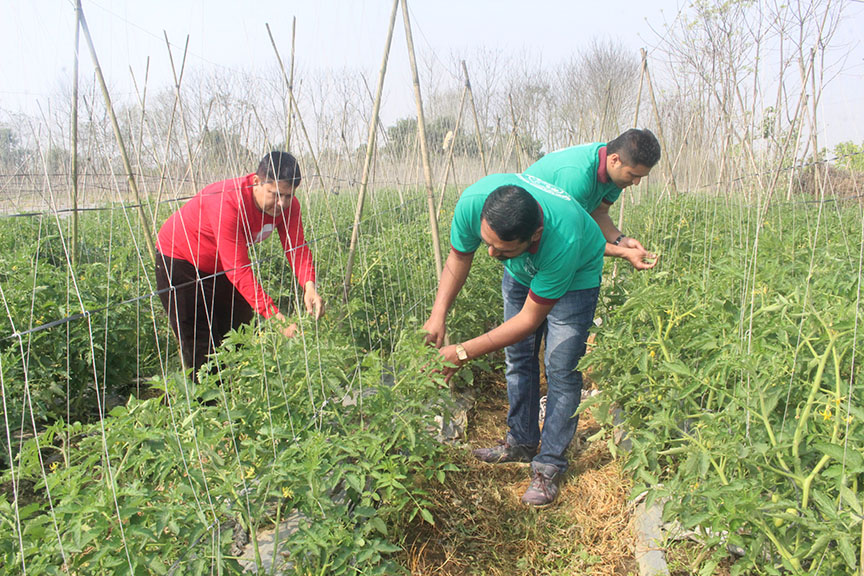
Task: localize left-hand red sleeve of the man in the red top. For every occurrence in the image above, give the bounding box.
[206,190,279,318]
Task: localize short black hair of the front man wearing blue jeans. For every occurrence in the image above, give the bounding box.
[480,186,540,242]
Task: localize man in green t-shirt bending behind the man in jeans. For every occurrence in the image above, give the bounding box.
[525,128,660,270]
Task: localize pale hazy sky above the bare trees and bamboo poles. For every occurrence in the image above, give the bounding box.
[0,0,864,142]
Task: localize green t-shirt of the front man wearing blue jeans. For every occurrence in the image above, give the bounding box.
[450,174,606,300]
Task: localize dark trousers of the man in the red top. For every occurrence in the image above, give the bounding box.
[156,253,255,380]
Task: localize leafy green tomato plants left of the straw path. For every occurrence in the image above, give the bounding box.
[0,192,495,574]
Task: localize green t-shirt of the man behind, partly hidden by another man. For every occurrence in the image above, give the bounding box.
[525,142,621,214]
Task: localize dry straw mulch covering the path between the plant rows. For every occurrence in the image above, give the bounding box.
[404,374,637,576]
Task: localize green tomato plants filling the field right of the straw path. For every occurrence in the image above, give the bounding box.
[583,192,864,574]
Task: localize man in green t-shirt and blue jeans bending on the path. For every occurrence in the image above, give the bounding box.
[423,174,605,506]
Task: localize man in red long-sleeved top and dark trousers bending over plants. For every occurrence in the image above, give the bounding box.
[156,152,324,378]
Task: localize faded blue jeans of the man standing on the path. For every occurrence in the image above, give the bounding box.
[501,270,600,474]
